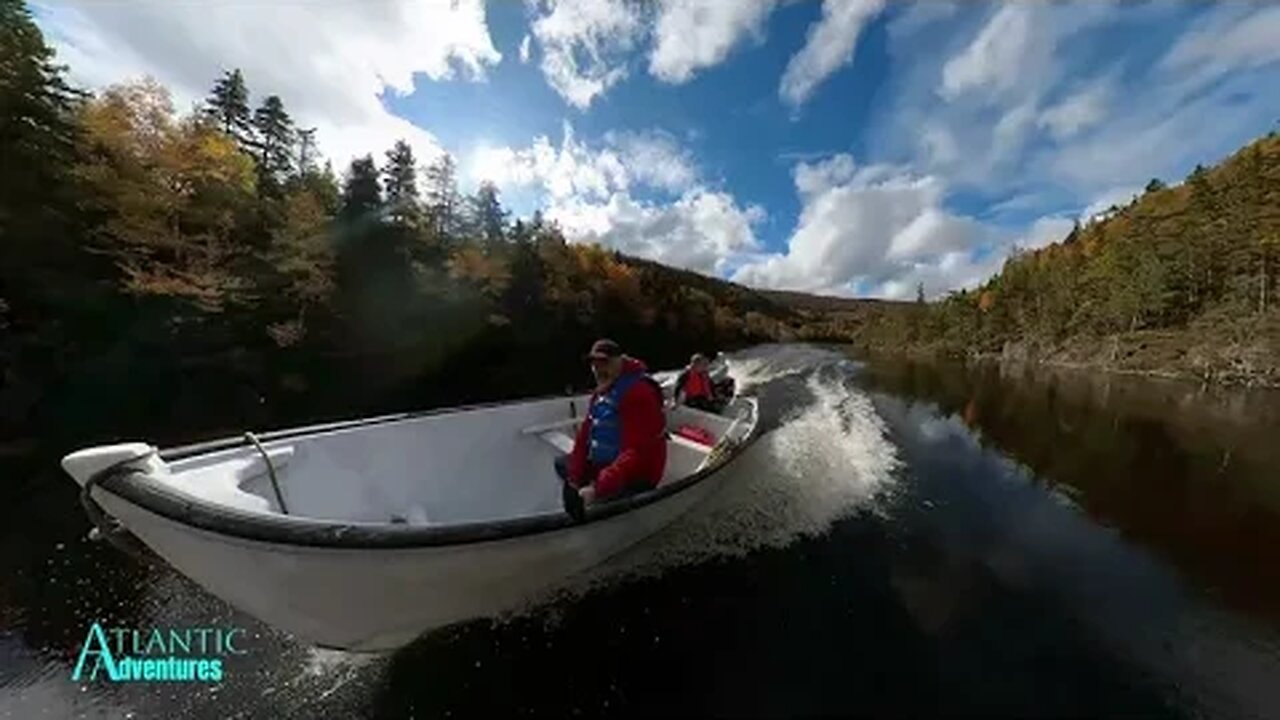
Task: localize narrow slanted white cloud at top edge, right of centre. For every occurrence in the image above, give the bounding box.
[778,0,884,106]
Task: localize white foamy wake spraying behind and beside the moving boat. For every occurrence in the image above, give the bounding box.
[503,348,899,623]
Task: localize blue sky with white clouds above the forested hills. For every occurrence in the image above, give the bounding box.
[33,0,1280,299]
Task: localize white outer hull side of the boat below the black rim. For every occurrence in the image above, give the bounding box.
[92,458,723,652]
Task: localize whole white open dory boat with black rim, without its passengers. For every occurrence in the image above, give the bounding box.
[63,386,758,651]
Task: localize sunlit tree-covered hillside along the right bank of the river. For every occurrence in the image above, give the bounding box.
[771,132,1280,387]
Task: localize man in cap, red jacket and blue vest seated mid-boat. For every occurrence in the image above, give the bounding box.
[556,340,667,519]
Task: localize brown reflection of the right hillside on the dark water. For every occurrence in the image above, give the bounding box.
[864,360,1280,621]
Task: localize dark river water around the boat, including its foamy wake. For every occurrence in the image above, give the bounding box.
[0,346,1280,719]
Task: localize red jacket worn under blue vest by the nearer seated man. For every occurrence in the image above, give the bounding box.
[568,357,667,498]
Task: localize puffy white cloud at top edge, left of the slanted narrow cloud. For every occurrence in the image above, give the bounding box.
[649,0,778,83]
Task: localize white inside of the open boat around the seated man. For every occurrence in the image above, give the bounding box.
[115,396,756,525]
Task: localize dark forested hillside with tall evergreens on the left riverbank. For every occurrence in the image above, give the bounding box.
[0,0,804,466]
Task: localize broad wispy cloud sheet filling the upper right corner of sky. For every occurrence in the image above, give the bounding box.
[867,3,1280,208]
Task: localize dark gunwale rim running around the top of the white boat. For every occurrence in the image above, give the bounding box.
[95,396,760,548]
